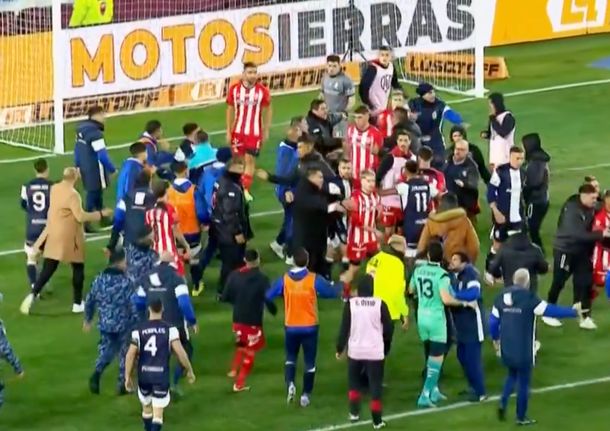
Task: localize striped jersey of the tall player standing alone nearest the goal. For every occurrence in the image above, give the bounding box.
[227,81,271,138]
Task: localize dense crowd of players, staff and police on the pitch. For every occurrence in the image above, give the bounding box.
[0,48,610,431]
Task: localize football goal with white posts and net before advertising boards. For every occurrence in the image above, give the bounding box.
[0,0,484,152]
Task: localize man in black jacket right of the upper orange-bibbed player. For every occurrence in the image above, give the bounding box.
[212,157,253,294]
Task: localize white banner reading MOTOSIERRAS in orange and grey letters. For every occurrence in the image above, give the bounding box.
[63,0,495,97]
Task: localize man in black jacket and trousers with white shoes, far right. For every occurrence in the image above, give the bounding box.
[542,184,610,329]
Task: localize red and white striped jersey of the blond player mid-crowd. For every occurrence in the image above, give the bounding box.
[347,190,381,245]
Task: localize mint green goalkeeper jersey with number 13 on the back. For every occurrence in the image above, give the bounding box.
[411,262,451,316]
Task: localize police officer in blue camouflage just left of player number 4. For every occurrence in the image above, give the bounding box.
[83,249,136,395]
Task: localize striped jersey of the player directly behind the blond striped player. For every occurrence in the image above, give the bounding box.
[347,124,383,181]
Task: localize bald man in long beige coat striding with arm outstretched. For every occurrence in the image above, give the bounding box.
[20,168,112,314]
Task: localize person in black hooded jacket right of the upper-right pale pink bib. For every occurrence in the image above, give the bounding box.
[521,133,551,253]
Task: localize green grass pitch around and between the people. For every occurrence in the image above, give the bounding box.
[0,35,610,431]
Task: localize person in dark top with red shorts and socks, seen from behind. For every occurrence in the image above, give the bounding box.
[221,249,277,392]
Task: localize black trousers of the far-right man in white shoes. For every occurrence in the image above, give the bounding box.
[548,250,593,318]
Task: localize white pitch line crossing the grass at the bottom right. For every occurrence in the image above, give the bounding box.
[309,376,610,431]
